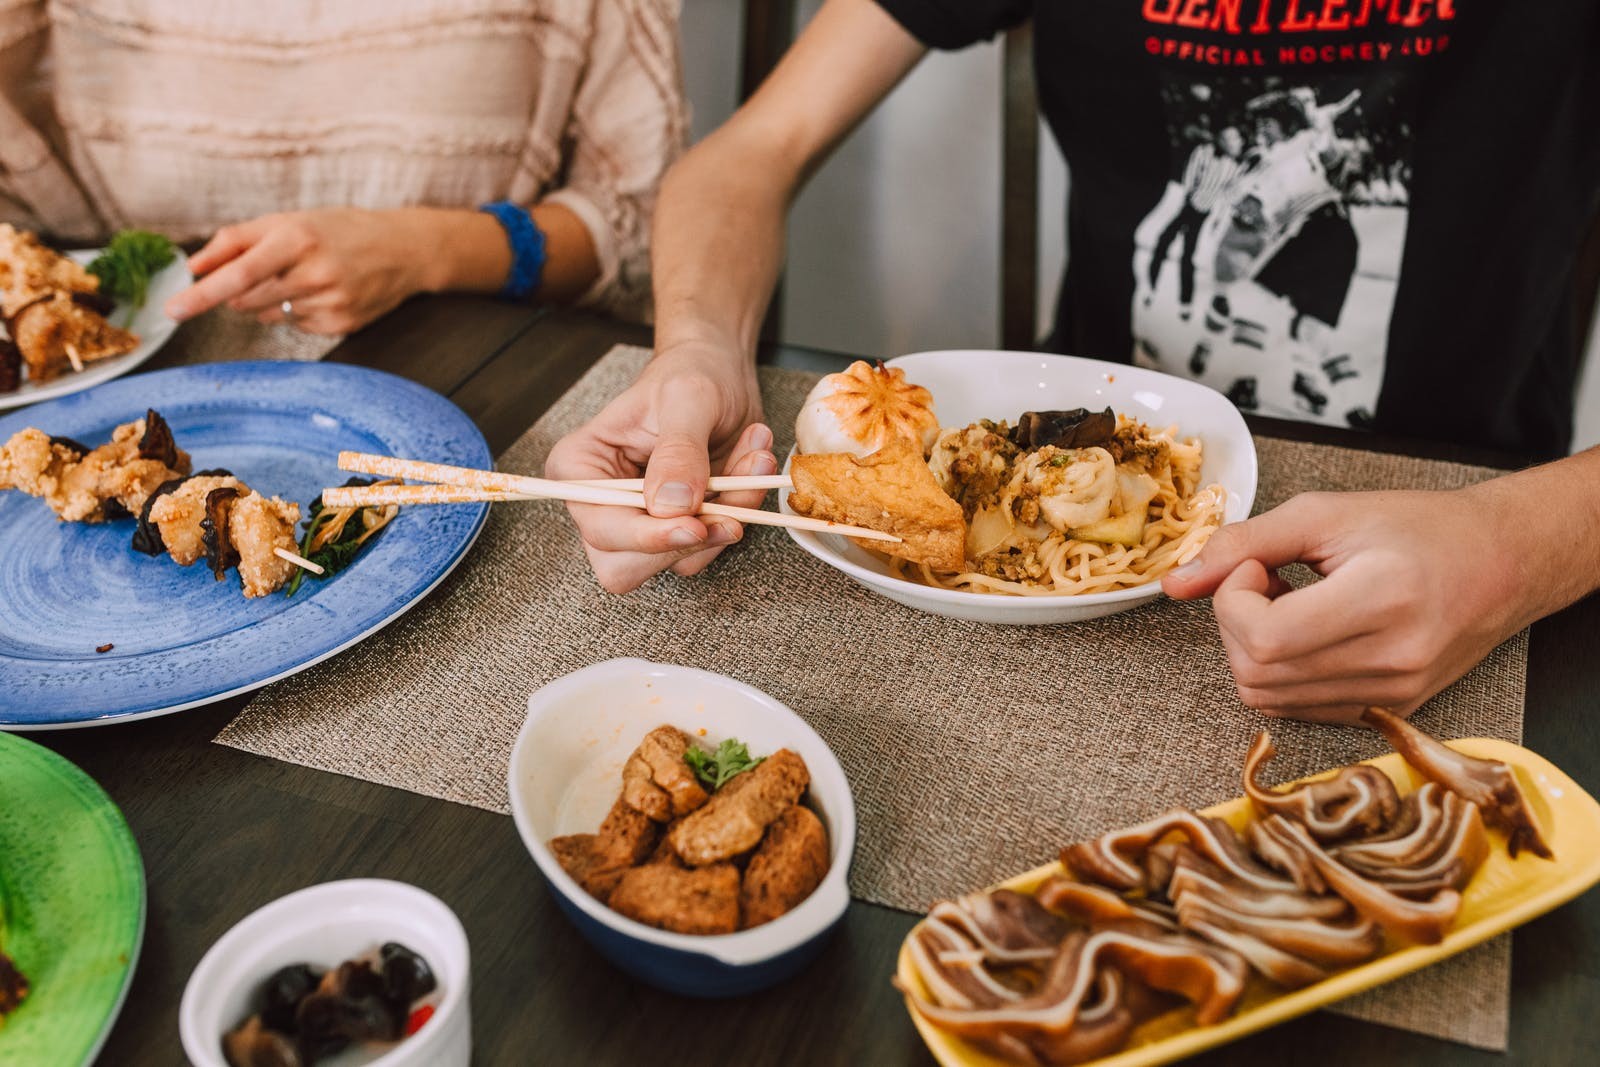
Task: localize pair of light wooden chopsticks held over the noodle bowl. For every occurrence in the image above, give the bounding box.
[322,453,899,541]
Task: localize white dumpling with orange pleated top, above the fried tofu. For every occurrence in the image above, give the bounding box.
[795,360,939,456]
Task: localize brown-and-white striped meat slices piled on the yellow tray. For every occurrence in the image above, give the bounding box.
[898,709,1550,1064]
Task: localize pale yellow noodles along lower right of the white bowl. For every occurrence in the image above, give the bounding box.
[880,427,1227,597]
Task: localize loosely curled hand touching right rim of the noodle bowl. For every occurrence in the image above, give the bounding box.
[1162,480,1546,721]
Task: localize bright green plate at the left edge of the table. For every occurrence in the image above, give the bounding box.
[0,733,144,1067]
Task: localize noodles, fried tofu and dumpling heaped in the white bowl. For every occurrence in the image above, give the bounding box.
[789,361,1227,597]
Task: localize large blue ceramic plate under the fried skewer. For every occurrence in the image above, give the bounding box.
[0,363,491,729]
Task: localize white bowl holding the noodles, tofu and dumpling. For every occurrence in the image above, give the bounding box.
[778,350,1256,625]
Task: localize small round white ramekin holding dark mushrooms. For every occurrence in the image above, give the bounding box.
[178,878,472,1067]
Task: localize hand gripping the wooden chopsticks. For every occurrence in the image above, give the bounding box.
[544,344,778,593]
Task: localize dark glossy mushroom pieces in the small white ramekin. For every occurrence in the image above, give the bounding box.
[222,941,438,1067]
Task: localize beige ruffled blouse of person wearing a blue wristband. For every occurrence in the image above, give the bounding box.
[0,0,688,318]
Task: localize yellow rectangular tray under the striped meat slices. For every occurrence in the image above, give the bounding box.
[898,737,1600,1067]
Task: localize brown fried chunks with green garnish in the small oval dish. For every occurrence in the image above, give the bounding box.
[550,725,829,934]
